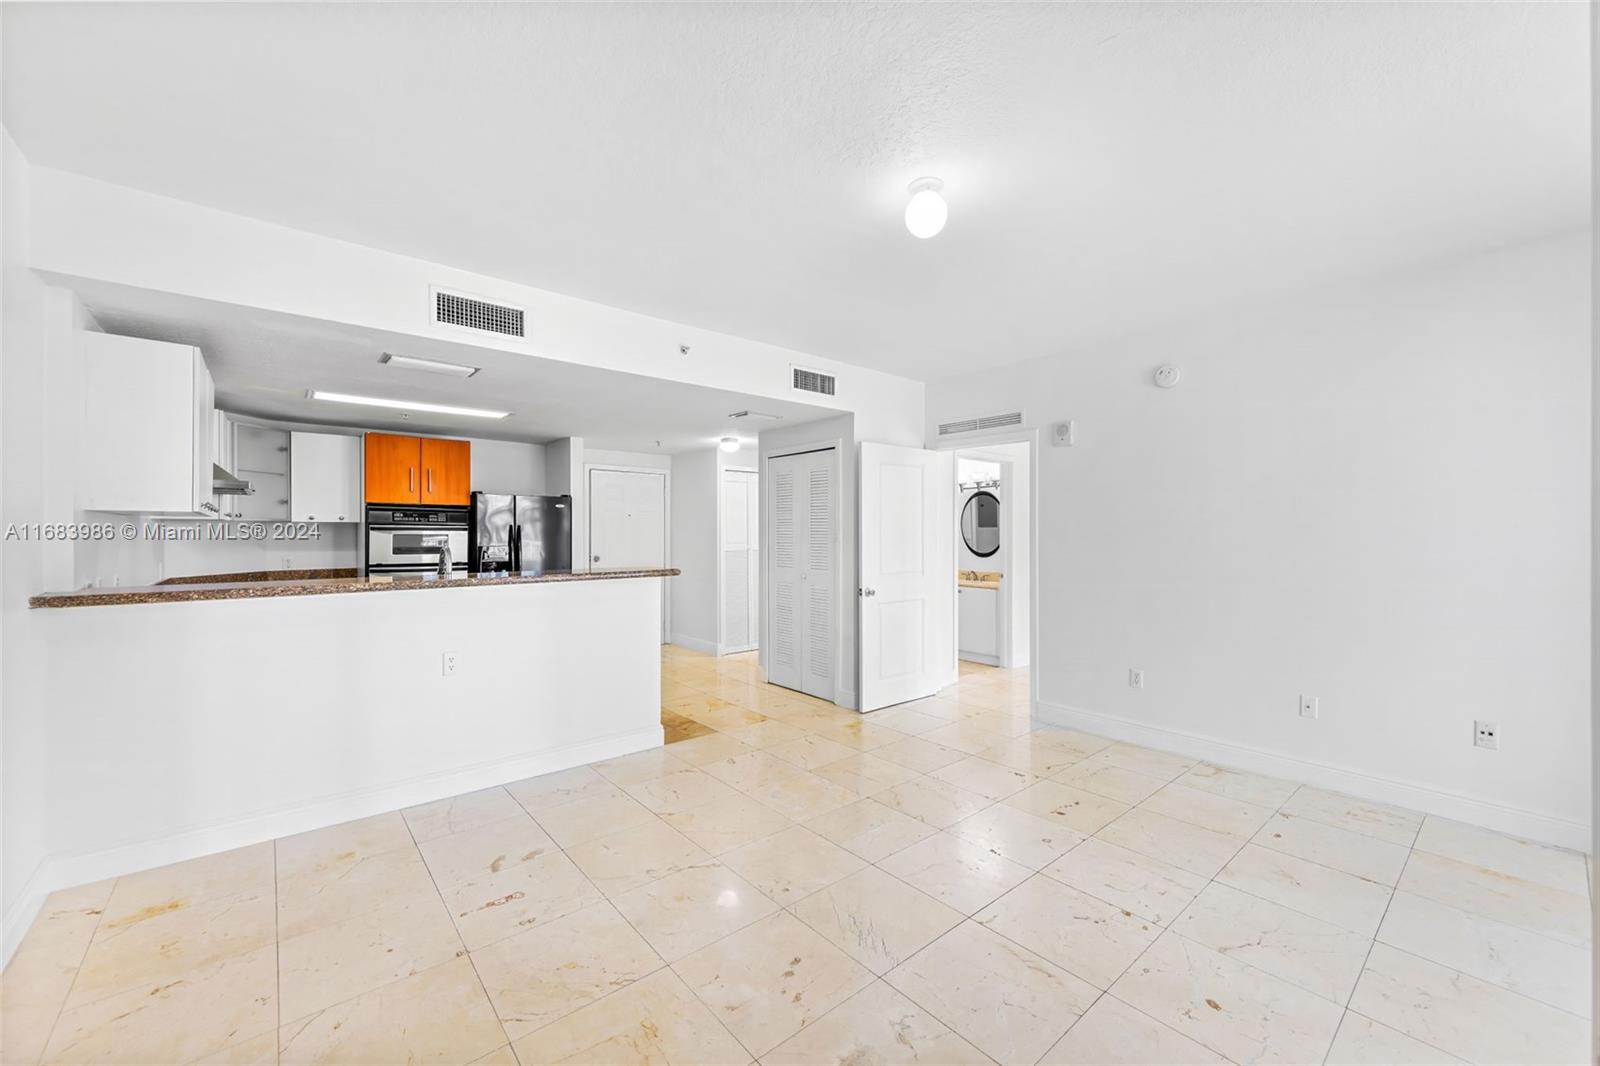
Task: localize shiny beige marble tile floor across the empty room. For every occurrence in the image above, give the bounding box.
[0,647,1590,1066]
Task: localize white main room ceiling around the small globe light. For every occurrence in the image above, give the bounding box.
[0,3,1589,378]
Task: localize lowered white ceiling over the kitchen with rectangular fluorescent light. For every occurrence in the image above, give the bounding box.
[77,283,837,455]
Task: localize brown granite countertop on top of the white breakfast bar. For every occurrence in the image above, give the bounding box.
[27,567,682,607]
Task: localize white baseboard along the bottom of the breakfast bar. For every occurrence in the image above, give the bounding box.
[0,723,664,965]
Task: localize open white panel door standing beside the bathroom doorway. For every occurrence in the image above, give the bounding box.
[858,443,955,711]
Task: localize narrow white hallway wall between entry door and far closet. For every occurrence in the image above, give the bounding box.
[670,448,722,653]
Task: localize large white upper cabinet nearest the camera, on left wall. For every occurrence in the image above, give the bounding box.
[78,333,218,517]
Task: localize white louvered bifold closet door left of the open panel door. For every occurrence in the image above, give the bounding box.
[766,448,838,701]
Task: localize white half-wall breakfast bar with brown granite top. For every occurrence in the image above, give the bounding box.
[32,568,678,884]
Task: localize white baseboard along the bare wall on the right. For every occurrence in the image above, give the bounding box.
[1034,701,1590,853]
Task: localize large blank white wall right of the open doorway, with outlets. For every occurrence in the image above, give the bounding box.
[926,234,1590,847]
